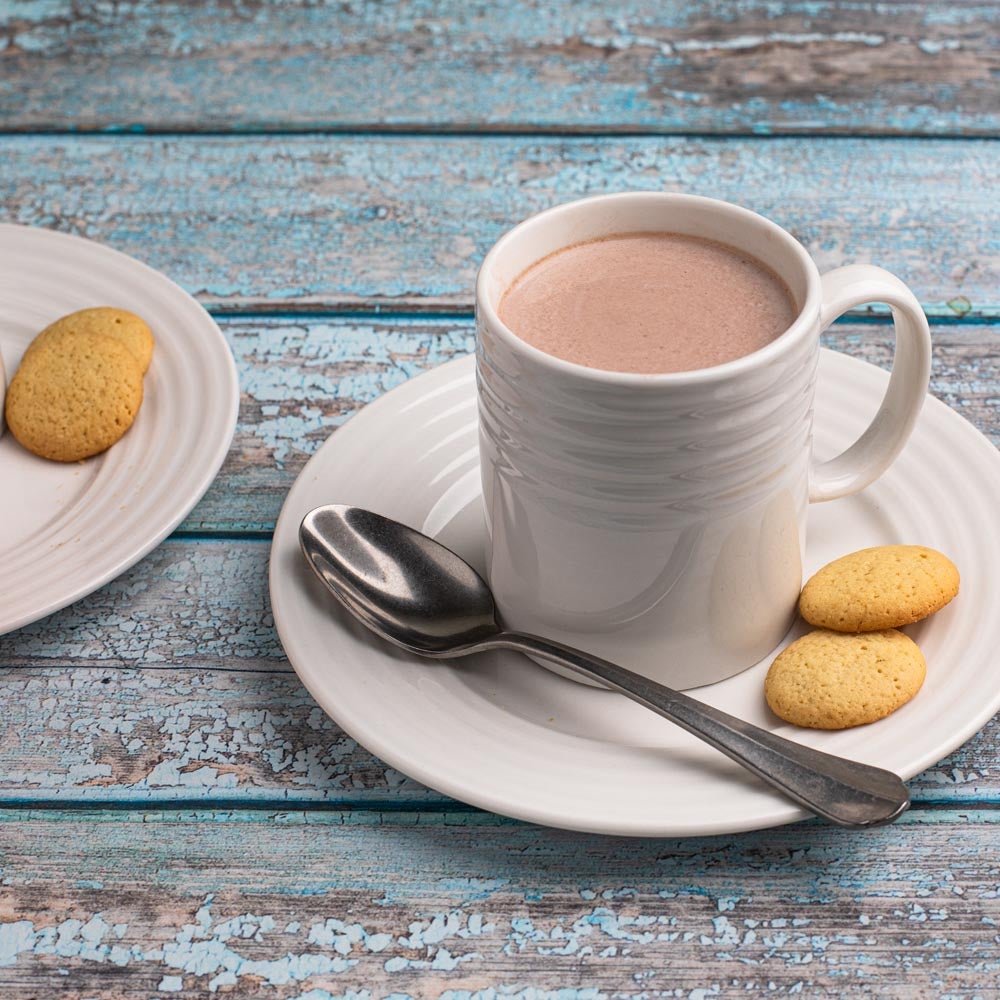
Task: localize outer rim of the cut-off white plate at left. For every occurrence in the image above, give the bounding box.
[0,222,240,636]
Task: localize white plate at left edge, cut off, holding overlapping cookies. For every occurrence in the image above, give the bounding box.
[0,225,239,635]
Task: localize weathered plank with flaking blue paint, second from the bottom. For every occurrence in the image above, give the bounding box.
[0,540,1000,806]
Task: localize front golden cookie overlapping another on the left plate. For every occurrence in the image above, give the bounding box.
[4,333,142,462]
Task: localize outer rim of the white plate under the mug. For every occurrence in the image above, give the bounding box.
[268,347,1000,837]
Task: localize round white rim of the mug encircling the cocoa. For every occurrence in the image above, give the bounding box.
[476,191,822,388]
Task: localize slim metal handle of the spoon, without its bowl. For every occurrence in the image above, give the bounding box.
[496,632,910,827]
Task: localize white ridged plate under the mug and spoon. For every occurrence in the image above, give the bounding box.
[271,351,1000,836]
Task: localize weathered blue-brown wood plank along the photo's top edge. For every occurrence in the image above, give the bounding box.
[0,0,1000,135]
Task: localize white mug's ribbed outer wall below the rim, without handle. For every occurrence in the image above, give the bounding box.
[477,317,819,686]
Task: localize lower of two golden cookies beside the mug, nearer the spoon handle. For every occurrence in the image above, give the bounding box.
[764,629,927,729]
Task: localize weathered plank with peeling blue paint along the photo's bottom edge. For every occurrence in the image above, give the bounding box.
[0,811,1000,1000]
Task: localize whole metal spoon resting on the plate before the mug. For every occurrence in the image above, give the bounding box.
[299,504,910,827]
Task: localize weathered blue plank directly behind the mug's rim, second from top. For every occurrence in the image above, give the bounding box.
[0,136,1000,317]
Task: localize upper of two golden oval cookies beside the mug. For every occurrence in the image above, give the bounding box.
[799,545,958,632]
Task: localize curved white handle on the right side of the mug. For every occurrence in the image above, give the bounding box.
[809,264,931,503]
